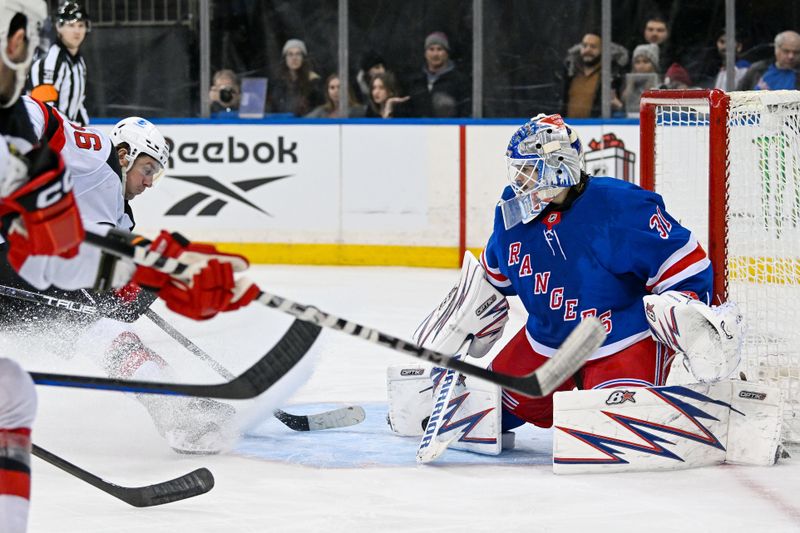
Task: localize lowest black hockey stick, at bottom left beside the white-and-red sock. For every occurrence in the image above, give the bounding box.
[32,444,214,507]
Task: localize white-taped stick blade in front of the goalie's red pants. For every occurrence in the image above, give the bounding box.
[536,317,606,396]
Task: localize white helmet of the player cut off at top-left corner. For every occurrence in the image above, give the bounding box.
[0,0,47,107]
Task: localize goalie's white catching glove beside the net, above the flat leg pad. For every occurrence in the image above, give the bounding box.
[643,291,745,383]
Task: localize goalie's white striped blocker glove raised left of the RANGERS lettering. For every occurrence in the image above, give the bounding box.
[412,251,508,357]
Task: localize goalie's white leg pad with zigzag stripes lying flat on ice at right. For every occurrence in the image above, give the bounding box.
[553,381,781,474]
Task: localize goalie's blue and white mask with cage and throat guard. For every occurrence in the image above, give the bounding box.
[500,115,583,229]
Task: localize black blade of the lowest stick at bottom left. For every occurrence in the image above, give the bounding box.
[115,468,214,507]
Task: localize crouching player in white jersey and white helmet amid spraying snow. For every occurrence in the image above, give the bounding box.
[0,100,255,453]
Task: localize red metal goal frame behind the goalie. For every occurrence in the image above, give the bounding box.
[639,89,730,304]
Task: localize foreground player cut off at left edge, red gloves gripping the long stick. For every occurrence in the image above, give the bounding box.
[0,0,257,533]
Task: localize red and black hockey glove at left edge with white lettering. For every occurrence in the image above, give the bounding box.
[0,146,84,271]
